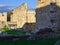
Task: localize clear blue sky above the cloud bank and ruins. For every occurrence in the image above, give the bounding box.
[0,0,36,9]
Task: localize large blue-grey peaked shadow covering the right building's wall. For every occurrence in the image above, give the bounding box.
[35,3,60,30]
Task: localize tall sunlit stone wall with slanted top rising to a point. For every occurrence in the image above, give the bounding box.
[11,3,27,28]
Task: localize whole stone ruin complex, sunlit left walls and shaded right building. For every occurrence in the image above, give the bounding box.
[0,0,60,31]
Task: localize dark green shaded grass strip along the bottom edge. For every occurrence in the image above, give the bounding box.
[0,39,57,45]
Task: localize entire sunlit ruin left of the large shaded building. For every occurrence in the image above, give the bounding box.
[0,3,36,30]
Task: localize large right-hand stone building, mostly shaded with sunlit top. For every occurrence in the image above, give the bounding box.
[35,0,60,30]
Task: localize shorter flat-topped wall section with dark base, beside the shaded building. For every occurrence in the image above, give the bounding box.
[26,10,36,31]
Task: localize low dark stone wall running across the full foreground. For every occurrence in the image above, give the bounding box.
[0,33,60,40]
